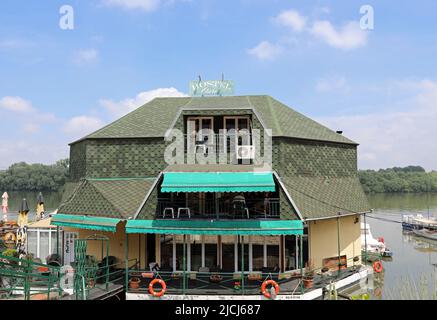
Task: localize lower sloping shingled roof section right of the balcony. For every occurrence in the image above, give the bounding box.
[281,176,370,219]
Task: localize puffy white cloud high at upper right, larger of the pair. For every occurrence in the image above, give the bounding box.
[311,20,368,50]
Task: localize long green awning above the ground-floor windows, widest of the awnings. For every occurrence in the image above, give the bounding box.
[126,220,303,236]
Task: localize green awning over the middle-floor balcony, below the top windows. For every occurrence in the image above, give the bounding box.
[161,172,275,192]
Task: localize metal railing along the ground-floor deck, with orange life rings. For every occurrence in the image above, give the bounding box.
[126,258,362,296]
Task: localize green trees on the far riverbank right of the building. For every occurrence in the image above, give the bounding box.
[358,166,437,193]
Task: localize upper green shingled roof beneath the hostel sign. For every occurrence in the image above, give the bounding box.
[76,96,355,144]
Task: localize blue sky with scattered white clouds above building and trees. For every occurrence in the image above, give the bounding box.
[0,0,437,170]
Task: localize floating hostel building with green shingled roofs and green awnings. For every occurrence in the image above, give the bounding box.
[52,90,369,299]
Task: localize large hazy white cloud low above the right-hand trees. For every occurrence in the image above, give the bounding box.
[318,80,437,170]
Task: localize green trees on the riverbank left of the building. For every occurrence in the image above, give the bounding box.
[0,159,69,192]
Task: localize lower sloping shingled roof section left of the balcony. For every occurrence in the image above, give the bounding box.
[58,178,156,219]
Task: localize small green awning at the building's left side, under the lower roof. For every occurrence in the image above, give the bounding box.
[52,213,121,232]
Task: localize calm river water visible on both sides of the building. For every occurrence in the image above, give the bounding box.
[3,192,437,299]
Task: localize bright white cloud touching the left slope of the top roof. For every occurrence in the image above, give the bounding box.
[100,87,187,117]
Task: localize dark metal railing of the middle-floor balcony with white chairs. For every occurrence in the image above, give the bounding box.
[156,198,281,219]
